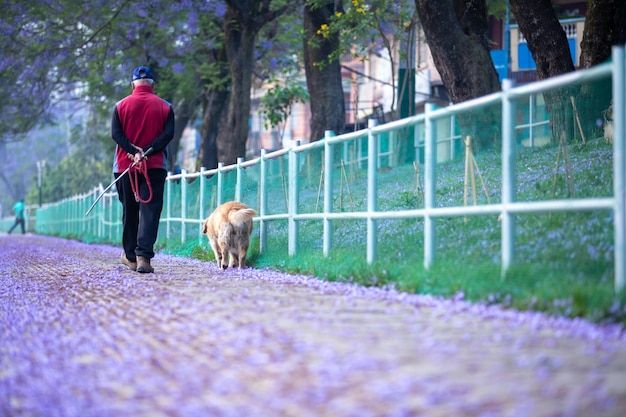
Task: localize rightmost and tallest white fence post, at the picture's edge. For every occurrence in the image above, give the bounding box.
[612,45,626,294]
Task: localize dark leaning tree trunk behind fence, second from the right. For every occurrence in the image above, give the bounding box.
[510,0,578,143]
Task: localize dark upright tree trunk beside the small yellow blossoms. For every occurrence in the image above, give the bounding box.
[304,1,346,142]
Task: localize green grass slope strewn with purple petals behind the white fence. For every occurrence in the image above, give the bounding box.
[163,140,626,325]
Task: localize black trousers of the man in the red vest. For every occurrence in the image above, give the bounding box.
[115,169,167,262]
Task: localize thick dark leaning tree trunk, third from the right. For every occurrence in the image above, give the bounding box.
[415,0,500,148]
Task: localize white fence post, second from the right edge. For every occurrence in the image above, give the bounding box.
[500,79,516,278]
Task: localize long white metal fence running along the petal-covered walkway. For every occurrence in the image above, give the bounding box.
[26,47,626,292]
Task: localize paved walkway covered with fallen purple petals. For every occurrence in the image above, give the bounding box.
[0,235,626,417]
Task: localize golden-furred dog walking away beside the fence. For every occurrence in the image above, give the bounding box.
[202,201,256,269]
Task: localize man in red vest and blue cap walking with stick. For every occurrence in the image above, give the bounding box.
[111,67,174,273]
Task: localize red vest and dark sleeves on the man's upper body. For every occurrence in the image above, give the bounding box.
[111,85,174,173]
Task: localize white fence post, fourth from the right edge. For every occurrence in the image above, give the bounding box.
[367,119,378,264]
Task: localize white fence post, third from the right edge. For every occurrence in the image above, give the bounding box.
[424,103,437,269]
